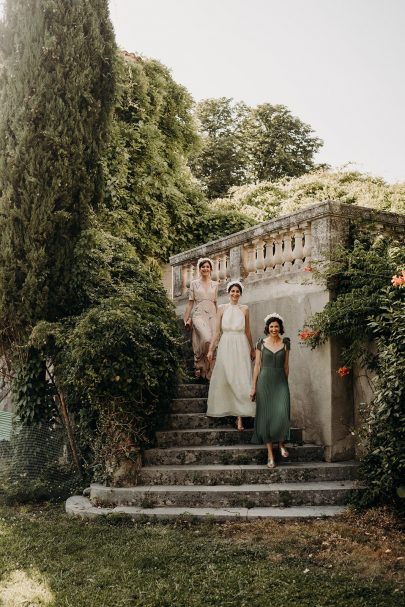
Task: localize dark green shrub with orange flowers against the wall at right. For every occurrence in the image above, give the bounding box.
[300,225,405,506]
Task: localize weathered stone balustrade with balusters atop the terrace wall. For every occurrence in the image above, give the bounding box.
[170,201,405,299]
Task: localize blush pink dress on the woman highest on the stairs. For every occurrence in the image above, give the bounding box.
[189,279,218,379]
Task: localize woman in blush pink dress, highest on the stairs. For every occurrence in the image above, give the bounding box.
[184,257,218,379]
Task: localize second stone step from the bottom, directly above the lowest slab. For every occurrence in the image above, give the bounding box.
[90,481,359,508]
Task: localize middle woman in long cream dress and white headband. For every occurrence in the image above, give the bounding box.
[207,280,256,431]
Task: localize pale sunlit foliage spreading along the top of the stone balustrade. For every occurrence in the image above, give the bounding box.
[210,169,405,223]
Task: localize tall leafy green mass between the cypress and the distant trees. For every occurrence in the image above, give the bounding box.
[100,55,206,260]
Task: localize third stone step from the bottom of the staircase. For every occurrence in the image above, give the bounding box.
[138,462,358,485]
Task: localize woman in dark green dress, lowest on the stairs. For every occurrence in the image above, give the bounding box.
[250,312,290,468]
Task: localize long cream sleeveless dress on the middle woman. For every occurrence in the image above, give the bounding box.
[207,304,256,417]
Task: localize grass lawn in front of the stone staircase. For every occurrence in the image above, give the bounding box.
[0,504,405,607]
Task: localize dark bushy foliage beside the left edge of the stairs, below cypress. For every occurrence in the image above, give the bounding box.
[30,224,180,480]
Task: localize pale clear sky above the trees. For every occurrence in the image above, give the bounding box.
[109,0,405,183]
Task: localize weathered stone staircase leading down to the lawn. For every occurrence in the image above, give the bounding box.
[66,384,361,520]
